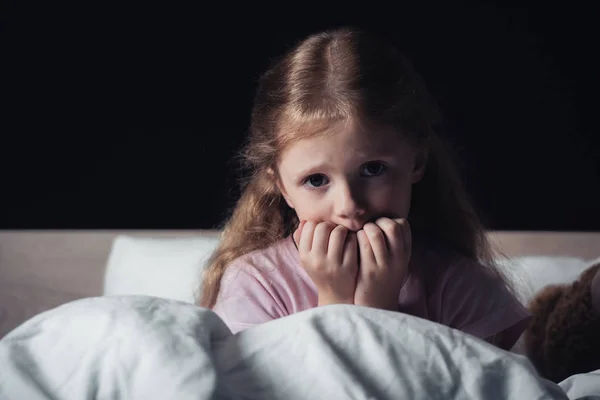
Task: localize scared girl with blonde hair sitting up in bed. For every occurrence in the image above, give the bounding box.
[200,28,530,349]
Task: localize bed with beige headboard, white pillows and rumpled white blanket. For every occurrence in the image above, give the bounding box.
[0,230,600,399]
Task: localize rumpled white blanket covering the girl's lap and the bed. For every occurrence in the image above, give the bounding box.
[0,296,600,400]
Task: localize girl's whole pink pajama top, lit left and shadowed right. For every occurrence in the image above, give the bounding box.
[213,237,531,350]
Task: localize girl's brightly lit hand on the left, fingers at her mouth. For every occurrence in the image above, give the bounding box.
[294,221,358,306]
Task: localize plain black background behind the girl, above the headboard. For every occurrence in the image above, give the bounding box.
[0,1,600,231]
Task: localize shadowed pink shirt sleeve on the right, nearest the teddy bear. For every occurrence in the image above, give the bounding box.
[440,259,531,350]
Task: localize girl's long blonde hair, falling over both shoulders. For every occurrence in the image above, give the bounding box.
[199,28,512,308]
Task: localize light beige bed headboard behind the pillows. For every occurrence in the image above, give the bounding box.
[0,230,600,337]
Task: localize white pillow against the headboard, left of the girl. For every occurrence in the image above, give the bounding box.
[103,235,219,304]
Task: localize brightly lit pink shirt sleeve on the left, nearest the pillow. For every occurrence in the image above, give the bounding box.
[213,262,288,333]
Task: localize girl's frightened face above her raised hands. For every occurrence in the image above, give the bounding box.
[278,119,426,231]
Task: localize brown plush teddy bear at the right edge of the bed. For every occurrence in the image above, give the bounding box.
[525,261,600,383]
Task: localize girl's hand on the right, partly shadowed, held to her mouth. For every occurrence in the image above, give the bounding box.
[354,218,412,311]
